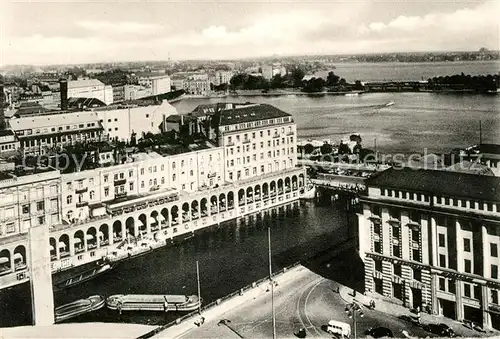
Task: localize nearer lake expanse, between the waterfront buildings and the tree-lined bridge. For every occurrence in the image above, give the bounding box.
[174,93,500,153]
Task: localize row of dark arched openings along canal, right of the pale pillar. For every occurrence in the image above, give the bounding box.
[45,175,304,261]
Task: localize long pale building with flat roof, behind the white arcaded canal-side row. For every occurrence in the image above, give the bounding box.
[9,101,177,154]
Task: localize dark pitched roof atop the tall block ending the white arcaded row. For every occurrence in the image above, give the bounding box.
[220,104,291,126]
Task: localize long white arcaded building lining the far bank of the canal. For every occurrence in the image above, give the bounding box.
[0,106,305,288]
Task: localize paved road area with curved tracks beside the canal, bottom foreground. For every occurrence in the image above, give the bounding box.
[180,271,442,338]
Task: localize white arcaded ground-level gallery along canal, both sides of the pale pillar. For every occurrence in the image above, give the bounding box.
[0,168,305,289]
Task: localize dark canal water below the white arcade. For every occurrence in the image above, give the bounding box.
[0,202,352,327]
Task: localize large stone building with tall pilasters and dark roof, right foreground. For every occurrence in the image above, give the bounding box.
[358,168,500,329]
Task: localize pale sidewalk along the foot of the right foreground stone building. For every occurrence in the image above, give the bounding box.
[338,284,500,337]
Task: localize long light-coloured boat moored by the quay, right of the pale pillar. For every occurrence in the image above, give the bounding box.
[106,294,201,312]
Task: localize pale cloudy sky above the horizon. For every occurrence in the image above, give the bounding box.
[0,0,500,66]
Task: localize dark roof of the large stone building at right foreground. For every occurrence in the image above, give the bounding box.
[366,167,500,201]
